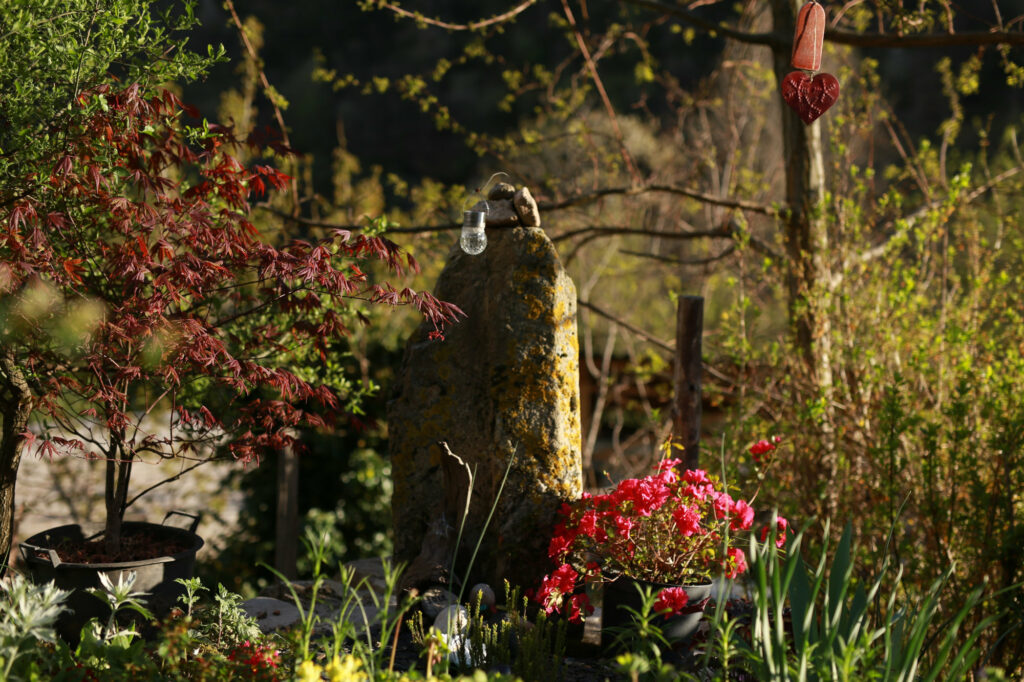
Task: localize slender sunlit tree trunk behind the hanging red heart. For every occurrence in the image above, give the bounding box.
[772,0,839,517]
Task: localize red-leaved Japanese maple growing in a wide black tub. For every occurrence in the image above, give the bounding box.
[0,84,461,552]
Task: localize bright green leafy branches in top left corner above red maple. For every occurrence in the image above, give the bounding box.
[0,0,223,204]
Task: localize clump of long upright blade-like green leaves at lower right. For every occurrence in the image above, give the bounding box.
[703,524,1011,682]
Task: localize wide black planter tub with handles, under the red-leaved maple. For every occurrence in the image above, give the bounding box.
[18,511,203,643]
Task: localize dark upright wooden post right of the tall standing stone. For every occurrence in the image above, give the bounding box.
[672,296,703,469]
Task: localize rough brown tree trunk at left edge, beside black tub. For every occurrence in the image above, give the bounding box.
[0,349,32,577]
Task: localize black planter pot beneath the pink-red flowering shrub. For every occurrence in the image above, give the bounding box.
[601,576,713,643]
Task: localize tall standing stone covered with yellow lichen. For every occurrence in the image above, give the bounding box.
[388,202,582,587]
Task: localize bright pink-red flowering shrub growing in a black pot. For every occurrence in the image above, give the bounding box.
[535,436,787,622]
